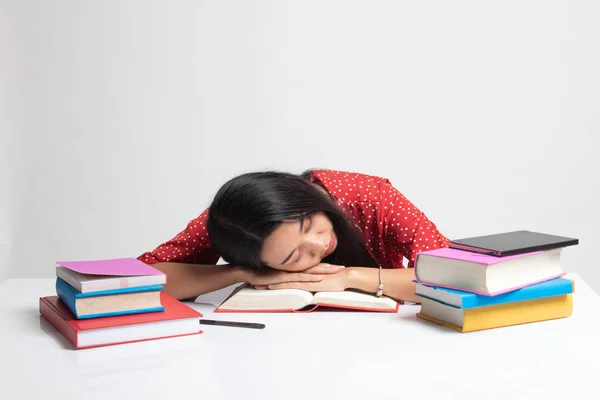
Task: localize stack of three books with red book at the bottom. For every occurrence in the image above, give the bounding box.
[39,258,202,349]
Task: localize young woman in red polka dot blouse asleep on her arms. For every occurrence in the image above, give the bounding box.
[139,170,449,302]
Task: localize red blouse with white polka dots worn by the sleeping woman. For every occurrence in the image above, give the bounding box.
[138,170,450,268]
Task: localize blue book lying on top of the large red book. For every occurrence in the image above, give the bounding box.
[56,278,164,319]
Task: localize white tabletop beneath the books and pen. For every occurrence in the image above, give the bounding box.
[0,276,600,400]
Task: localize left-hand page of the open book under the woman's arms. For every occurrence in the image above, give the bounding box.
[214,287,313,311]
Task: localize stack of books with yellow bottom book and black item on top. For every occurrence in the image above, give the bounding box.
[415,231,579,332]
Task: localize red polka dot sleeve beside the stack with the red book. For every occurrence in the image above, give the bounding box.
[138,209,220,265]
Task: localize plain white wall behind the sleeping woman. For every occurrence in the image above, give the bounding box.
[0,0,600,291]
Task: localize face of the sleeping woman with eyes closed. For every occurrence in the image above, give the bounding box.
[260,213,338,271]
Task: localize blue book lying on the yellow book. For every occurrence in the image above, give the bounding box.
[416,278,574,309]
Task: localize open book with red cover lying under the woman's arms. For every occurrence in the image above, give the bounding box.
[215,285,399,312]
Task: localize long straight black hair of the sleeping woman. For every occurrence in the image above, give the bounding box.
[207,171,377,268]
